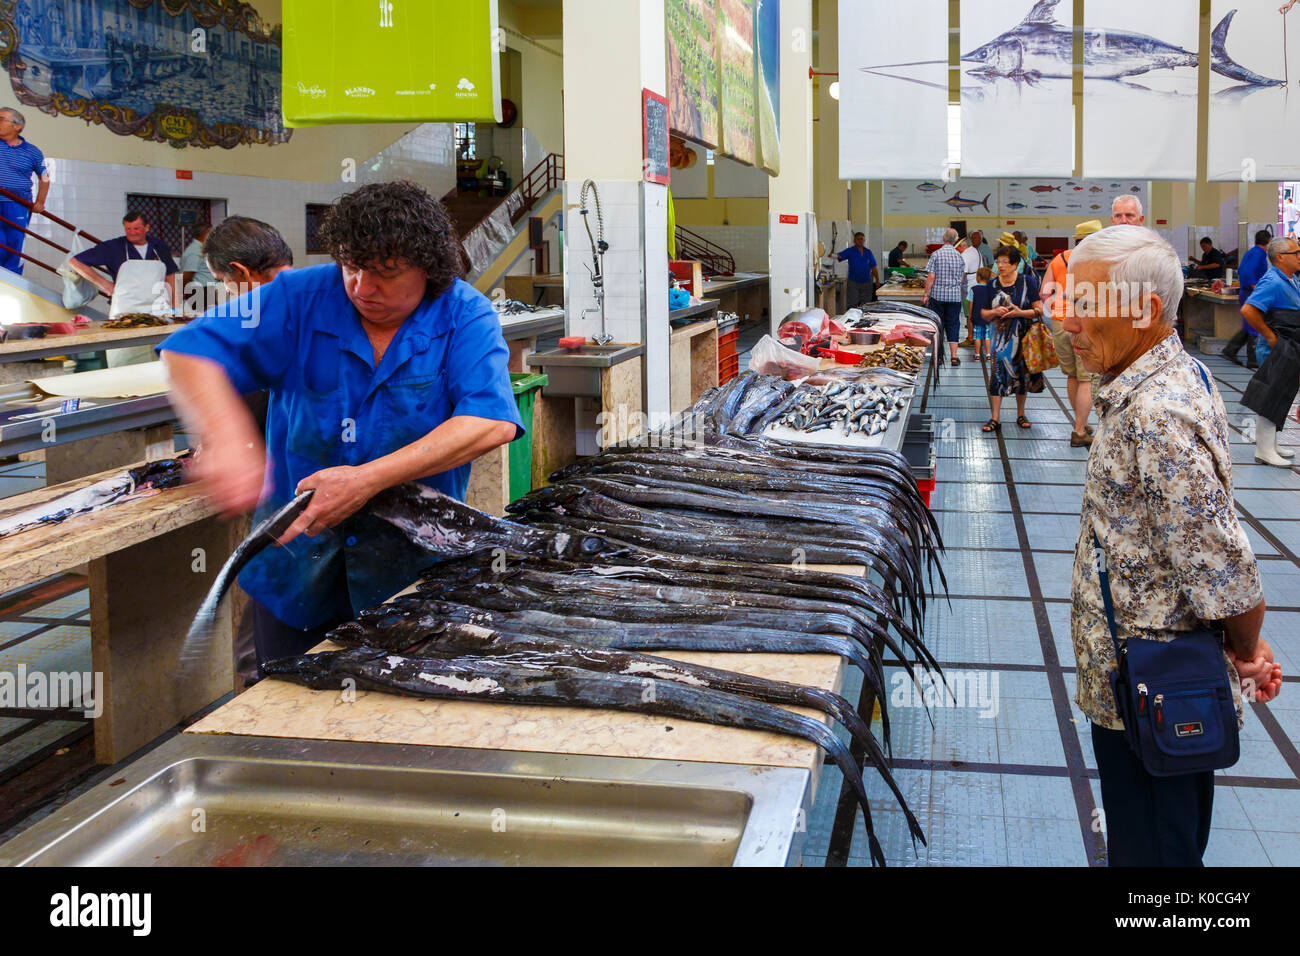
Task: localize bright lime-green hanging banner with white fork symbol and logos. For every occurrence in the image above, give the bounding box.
[281,0,503,126]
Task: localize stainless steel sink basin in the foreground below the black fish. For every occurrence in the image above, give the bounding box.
[0,734,810,866]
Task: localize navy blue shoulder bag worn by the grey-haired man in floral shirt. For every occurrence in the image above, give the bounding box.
[1092,363,1242,777]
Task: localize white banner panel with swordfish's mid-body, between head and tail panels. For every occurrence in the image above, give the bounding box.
[1076,0,1200,181]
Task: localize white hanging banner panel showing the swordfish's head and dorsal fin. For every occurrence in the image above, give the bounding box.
[961,0,1074,178]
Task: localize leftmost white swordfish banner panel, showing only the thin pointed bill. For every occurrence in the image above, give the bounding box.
[840,0,948,179]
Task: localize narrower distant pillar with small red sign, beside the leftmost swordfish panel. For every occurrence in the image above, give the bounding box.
[767,0,816,330]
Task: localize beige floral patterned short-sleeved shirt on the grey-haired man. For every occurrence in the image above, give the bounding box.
[1070,334,1264,730]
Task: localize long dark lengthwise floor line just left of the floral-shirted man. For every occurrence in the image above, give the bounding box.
[980,360,1105,866]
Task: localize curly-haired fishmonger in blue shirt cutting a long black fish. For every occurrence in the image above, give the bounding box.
[159,182,523,662]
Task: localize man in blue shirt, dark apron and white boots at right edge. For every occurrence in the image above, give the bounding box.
[1242,238,1300,468]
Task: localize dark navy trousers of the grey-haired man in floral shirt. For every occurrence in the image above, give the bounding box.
[1092,724,1214,866]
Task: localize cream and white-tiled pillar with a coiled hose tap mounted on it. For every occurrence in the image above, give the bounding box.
[564,0,668,416]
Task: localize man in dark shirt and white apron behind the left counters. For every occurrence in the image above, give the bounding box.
[68,212,181,368]
